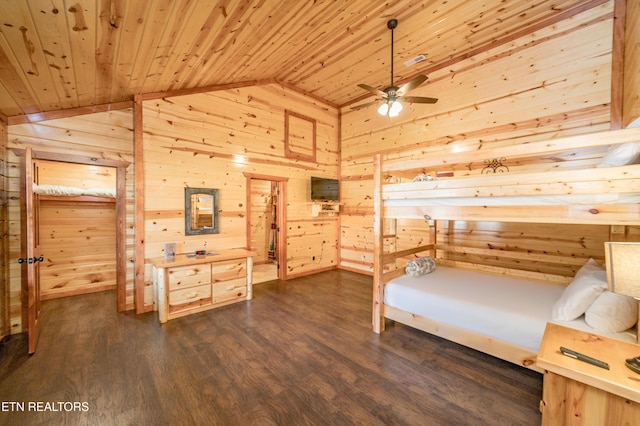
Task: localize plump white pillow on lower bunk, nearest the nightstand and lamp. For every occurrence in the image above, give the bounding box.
[584,291,638,333]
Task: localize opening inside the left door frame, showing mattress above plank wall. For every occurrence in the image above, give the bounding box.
[34,160,117,300]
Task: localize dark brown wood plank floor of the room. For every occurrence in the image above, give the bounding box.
[0,270,542,425]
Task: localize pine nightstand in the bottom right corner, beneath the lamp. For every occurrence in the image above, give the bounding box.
[537,323,640,426]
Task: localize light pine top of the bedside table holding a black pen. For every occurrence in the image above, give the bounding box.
[537,323,640,403]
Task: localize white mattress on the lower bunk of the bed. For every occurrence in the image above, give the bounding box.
[384,266,636,352]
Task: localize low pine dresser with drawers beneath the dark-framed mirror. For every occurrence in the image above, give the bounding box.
[151,249,255,323]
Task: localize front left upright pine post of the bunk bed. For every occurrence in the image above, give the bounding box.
[371,154,384,333]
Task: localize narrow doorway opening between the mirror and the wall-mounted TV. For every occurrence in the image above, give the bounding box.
[245,174,286,284]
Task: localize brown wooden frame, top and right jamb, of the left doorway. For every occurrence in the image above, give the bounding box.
[13,149,130,312]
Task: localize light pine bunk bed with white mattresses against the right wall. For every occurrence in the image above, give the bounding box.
[372,128,640,370]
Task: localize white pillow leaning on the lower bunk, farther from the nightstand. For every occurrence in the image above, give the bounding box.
[551,259,607,321]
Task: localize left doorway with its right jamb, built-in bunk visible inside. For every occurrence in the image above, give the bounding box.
[18,151,129,304]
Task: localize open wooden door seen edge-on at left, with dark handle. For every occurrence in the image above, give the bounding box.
[19,148,41,354]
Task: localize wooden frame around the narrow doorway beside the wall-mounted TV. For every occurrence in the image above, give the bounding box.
[243,173,289,280]
